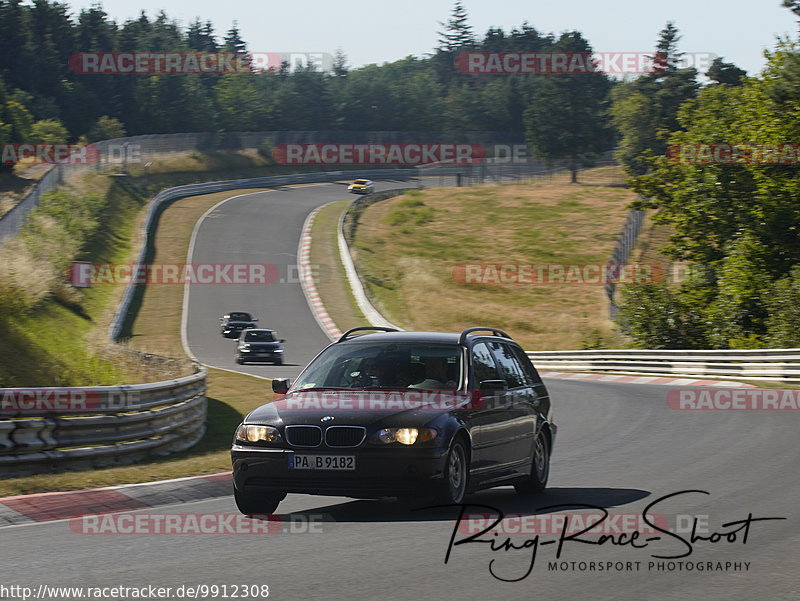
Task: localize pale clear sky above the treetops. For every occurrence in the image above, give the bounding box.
[67,0,798,75]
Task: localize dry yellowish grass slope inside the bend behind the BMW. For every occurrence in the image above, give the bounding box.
[353,168,635,350]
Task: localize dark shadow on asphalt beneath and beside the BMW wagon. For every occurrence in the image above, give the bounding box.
[260,487,650,522]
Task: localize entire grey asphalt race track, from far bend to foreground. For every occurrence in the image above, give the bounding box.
[3,182,800,601]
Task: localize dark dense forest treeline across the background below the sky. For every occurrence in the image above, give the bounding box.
[0,0,613,166]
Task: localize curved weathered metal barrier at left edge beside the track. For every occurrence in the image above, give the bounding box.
[0,367,207,475]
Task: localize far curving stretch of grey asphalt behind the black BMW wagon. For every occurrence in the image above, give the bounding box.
[186,176,416,378]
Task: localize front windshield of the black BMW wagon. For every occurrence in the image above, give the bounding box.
[292,343,464,390]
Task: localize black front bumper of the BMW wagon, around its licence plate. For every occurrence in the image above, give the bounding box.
[231,445,454,499]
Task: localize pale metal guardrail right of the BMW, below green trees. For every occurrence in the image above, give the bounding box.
[526,349,800,382]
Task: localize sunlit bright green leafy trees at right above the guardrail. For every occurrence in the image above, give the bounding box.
[614,0,800,348]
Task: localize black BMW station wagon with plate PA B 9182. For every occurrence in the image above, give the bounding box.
[231,327,556,514]
